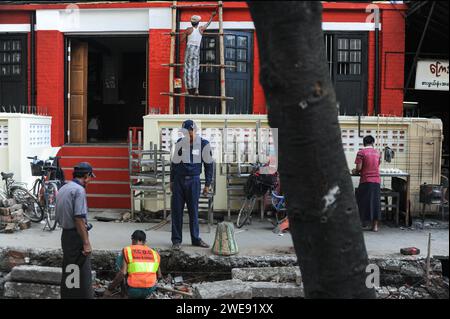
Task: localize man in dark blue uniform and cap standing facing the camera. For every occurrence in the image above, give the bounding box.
[170,120,213,250]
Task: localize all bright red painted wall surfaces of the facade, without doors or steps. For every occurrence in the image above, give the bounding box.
[0,2,405,146]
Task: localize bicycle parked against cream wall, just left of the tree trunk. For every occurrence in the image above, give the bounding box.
[236,164,278,228]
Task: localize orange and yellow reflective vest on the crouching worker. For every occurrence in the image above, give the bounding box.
[123,245,160,288]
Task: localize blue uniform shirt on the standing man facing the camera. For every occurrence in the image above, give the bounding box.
[170,135,213,186]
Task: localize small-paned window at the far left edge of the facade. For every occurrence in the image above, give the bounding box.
[0,40,22,76]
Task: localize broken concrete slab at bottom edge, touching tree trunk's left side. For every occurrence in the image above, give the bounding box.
[245,282,305,298]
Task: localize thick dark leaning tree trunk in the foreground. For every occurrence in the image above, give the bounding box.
[248,1,375,298]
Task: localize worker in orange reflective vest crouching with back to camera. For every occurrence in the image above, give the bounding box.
[104,230,162,299]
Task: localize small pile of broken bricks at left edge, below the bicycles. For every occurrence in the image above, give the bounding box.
[0,198,31,234]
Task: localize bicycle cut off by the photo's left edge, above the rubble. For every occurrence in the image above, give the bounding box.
[0,172,44,223]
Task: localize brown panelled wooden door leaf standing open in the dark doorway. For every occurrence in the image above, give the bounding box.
[69,41,88,143]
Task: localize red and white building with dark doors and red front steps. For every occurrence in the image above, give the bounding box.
[0,1,407,207]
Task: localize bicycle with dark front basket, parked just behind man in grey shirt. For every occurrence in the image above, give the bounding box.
[27,156,64,230]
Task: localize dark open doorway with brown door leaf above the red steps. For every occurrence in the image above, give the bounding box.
[66,36,148,144]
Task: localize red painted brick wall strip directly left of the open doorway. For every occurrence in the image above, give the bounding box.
[36,31,64,146]
